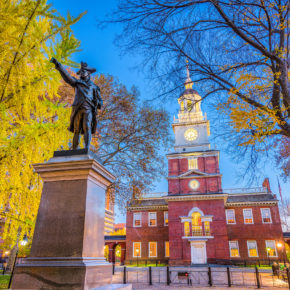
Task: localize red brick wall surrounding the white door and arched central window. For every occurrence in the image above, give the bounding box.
[168,200,229,265]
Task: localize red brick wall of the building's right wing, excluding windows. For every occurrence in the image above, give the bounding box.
[227,205,284,260]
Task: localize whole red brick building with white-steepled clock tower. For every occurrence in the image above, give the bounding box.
[126,64,285,265]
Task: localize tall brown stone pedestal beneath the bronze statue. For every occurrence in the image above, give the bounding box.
[12,150,115,289]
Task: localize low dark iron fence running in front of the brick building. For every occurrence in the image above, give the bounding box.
[113,266,290,289]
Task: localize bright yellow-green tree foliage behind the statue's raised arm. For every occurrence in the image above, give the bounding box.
[0,0,82,248]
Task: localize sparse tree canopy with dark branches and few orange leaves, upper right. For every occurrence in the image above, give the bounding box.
[111,0,290,180]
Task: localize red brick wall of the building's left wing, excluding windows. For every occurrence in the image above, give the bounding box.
[126,210,169,262]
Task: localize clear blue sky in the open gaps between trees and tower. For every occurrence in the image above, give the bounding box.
[48,0,290,223]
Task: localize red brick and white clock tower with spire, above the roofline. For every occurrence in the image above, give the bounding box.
[167,64,222,195]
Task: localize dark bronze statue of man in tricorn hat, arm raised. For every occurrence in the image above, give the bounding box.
[51,58,103,149]
